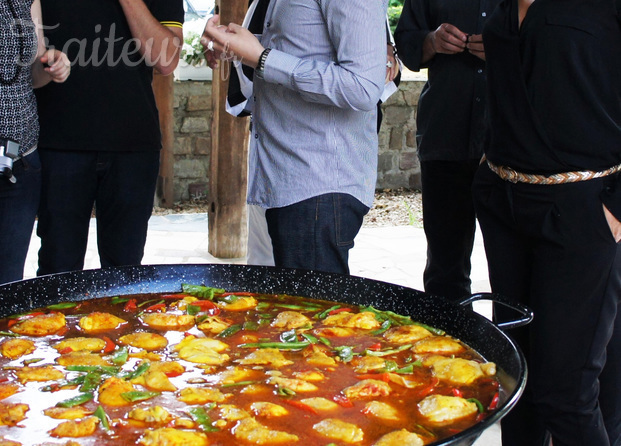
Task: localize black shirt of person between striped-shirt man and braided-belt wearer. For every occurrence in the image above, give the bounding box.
[395,0,500,161]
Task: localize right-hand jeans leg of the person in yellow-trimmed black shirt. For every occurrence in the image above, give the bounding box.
[95,151,160,267]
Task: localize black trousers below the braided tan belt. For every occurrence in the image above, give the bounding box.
[474,164,621,446]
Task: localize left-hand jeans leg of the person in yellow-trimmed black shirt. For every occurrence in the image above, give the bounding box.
[37,149,97,276]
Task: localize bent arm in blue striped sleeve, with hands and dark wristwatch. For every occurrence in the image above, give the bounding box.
[202,0,386,110]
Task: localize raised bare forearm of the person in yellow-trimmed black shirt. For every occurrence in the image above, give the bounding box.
[119,0,183,75]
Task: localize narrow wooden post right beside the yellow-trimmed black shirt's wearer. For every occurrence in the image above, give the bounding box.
[153,73,175,208]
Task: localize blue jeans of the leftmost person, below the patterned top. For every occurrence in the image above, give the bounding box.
[0,151,41,284]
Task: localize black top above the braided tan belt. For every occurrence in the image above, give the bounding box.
[483,0,621,217]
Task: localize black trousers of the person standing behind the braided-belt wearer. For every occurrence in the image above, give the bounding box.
[421,159,479,299]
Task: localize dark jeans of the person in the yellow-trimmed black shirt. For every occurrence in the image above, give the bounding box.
[37,149,160,275]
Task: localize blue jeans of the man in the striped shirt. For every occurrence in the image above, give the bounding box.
[265,193,369,274]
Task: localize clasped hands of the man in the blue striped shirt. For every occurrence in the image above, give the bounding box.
[201,14,265,69]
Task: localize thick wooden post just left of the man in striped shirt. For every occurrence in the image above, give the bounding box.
[208,0,249,259]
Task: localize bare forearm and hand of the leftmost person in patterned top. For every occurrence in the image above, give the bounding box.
[30,0,71,88]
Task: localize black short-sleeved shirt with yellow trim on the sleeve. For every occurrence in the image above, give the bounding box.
[36,0,184,150]
